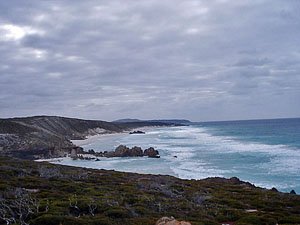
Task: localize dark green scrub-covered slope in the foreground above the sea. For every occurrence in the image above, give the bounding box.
[0,158,300,225]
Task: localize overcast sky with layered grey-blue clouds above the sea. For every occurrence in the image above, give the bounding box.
[0,0,300,121]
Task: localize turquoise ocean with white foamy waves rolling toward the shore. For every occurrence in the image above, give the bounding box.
[49,118,300,193]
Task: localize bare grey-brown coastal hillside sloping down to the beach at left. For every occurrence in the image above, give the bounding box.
[0,116,123,156]
